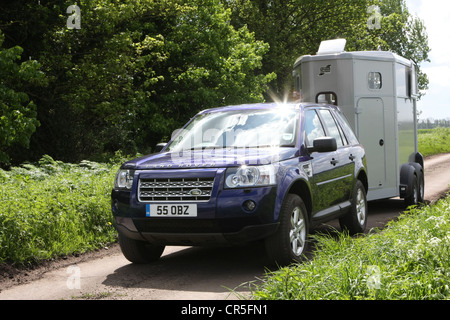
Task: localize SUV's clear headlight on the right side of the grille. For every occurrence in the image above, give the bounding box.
[225,165,275,188]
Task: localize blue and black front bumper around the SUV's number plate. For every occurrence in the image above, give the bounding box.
[111,174,278,246]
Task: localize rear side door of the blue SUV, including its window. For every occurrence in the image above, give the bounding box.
[318,109,355,206]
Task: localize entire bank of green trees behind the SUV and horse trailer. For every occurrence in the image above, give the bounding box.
[0,0,429,166]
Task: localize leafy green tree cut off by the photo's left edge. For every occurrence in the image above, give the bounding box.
[0,30,45,166]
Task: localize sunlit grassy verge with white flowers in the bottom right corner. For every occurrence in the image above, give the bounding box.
[253,197,450,300]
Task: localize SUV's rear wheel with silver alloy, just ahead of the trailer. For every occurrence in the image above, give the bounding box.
[339,180,368,235]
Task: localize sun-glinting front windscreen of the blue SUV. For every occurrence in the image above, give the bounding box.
[166,107,299,151]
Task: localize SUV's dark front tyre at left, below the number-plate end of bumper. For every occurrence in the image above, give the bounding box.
[119,233,165,264]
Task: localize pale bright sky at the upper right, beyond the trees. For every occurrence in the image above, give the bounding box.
[405,0,450,120]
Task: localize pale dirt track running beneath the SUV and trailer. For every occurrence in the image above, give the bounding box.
[0,154,450,300]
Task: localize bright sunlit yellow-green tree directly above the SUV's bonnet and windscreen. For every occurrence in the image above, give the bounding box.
[144,0,275,141]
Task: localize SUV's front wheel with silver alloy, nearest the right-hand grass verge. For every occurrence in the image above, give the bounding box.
[266,194,308,266]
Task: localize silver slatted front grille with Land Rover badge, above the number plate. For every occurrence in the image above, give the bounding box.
[138,178,214,202]
